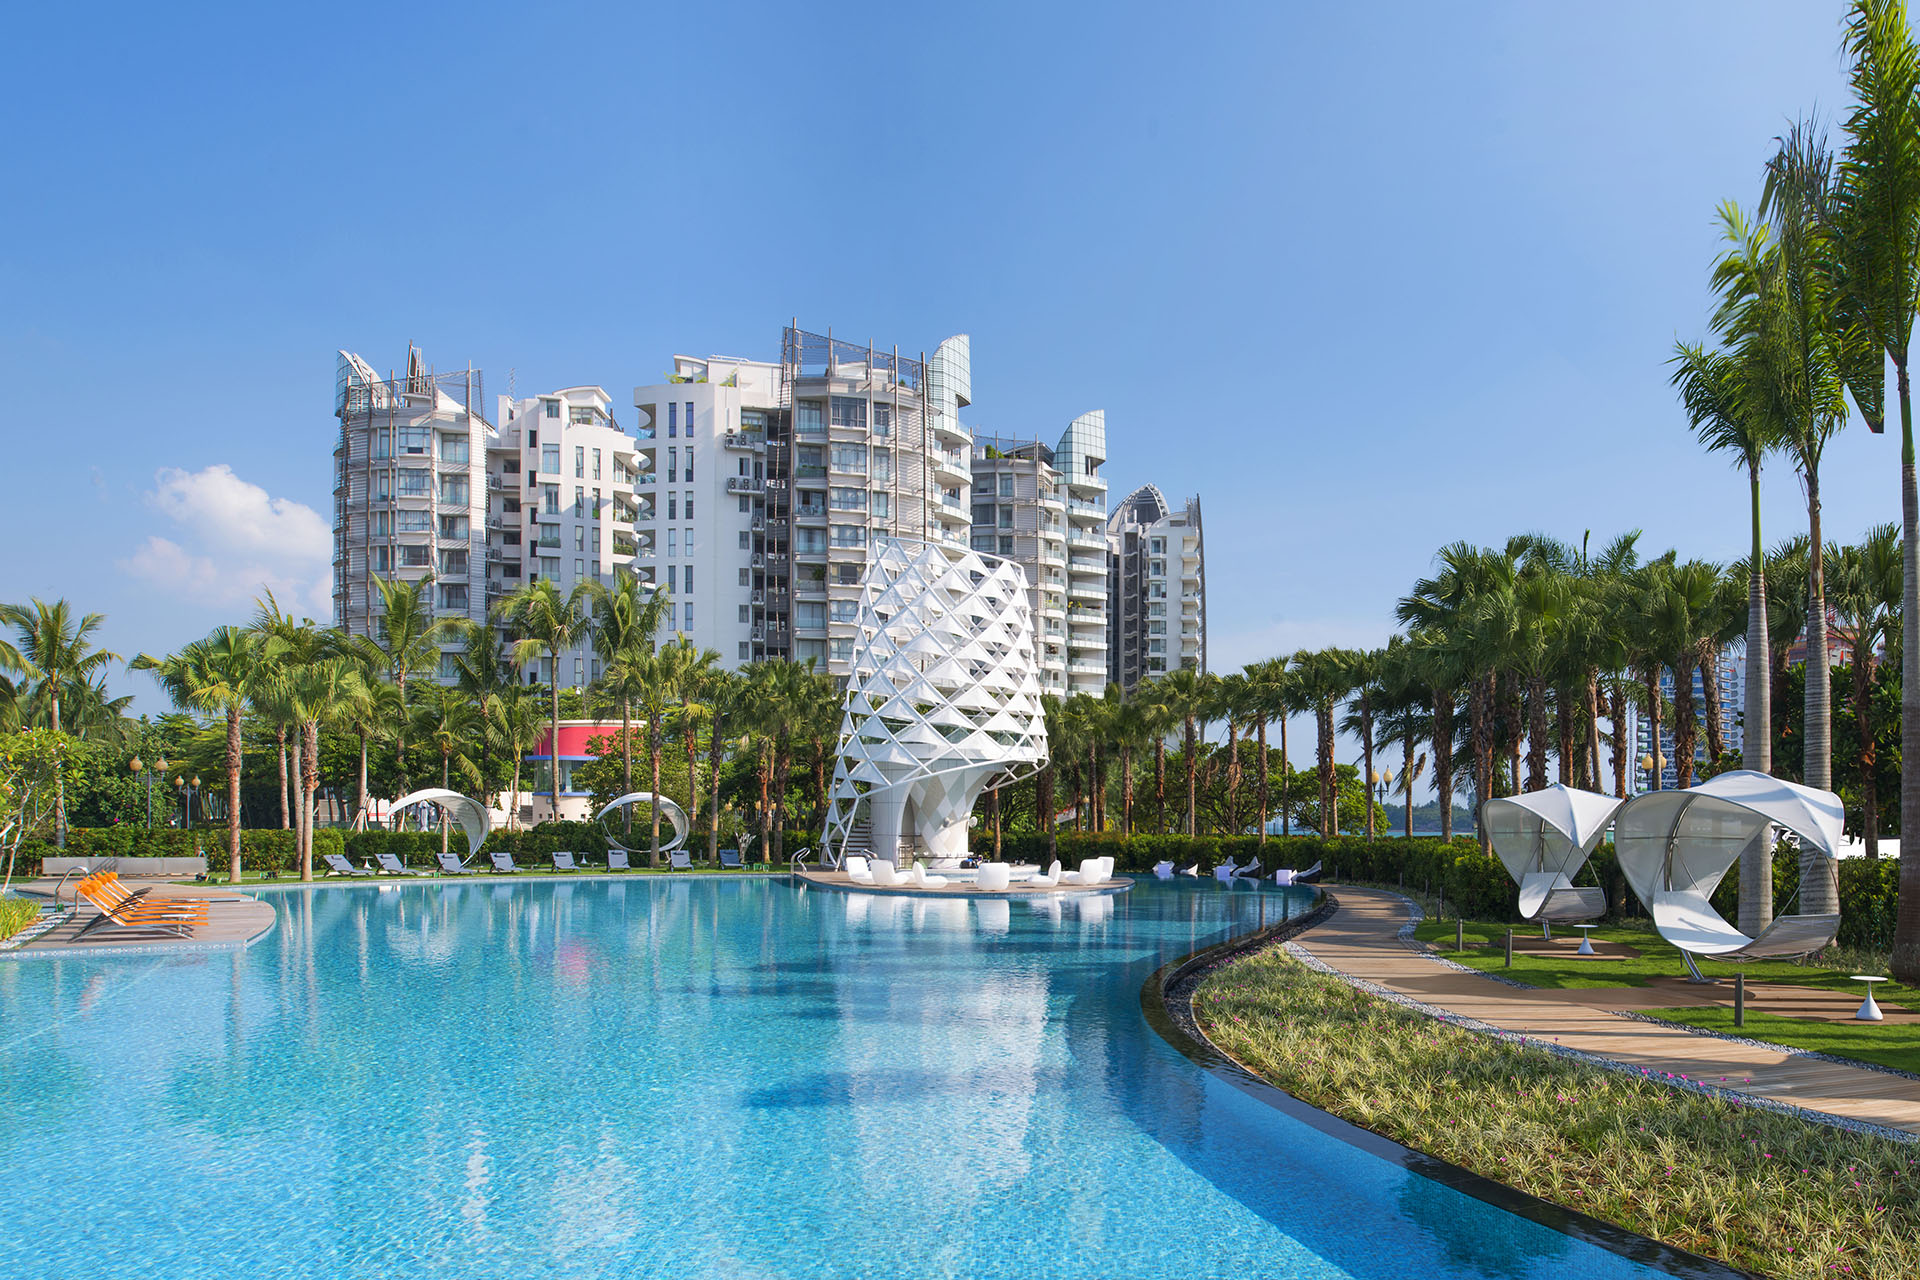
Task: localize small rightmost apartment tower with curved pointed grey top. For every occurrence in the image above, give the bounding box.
[1106,484,1206,691]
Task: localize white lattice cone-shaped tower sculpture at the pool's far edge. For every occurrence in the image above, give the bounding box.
[822,537,1046,865]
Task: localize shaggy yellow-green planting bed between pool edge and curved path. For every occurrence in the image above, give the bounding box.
[1194,948,1920,1280]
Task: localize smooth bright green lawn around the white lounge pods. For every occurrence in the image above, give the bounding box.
[1415,919,1920,1073]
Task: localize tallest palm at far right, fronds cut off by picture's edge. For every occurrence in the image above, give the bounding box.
[1809,0,1920,983]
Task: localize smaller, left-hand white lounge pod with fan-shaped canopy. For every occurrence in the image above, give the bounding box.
[1480,785,1622,938]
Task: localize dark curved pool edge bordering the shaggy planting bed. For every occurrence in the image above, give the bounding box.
[1140,889,1751,1280]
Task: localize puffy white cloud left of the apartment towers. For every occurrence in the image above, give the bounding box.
[117,464,332,622]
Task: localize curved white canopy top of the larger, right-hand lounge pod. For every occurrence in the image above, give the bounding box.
[1613,770,1843,910]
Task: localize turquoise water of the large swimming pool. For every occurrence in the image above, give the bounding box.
[0,879,1681,1280]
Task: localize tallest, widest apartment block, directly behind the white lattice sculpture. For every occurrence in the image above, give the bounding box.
[634,326,972,676]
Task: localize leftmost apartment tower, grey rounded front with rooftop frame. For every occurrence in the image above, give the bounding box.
[334,347,493,668]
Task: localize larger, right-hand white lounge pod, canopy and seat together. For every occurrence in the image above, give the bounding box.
[1613,770,1843,977]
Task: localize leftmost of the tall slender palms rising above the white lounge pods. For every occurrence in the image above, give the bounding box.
[1672,342,1786,773]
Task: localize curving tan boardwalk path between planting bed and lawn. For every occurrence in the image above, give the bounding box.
[1294,885,1920,1134]
